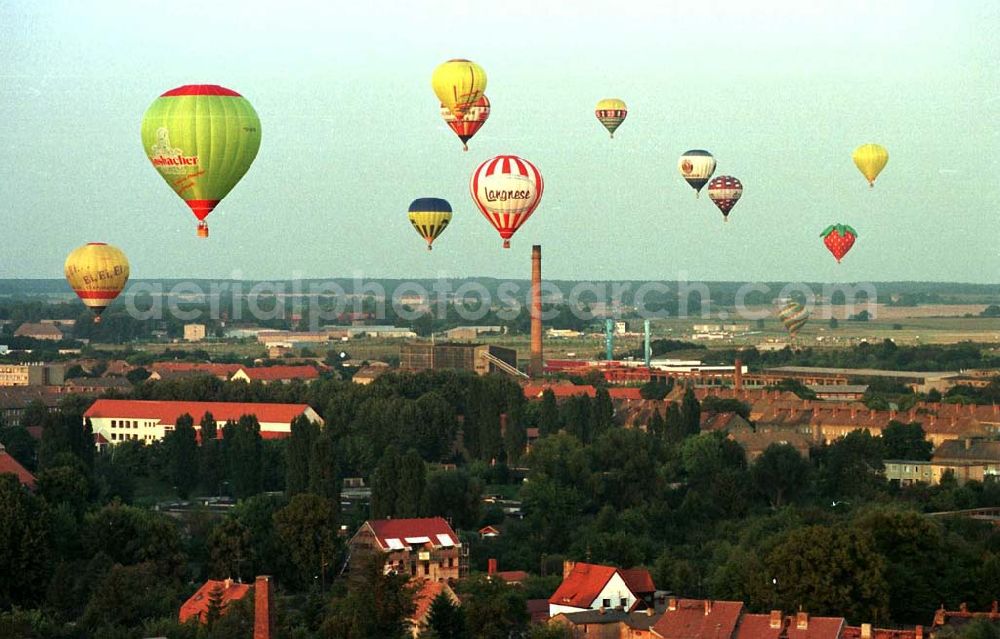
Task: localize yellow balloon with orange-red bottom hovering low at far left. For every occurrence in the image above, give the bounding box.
[64,242,128,322]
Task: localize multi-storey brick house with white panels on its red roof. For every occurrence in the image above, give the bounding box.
[347,517,468,581]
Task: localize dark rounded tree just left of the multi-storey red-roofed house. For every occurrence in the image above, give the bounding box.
[274,493,338,590]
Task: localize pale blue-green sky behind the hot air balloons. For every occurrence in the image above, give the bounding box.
[0,0,1000,283]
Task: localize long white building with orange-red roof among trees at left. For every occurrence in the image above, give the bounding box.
[83,399,323,445]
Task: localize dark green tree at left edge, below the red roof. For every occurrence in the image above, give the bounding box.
[0,474,52,610]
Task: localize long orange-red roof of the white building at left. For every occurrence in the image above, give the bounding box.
[84,399,318,431]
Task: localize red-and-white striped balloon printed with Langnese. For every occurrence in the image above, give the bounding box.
[469,155,543,248]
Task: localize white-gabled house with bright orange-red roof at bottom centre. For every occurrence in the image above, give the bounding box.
[549,561,655,617]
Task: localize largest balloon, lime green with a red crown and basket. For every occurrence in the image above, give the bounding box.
[142,84,260,237]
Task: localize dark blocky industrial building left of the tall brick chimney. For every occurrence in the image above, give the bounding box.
[399,342,523,376]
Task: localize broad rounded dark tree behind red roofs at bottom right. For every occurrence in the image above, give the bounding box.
[766,526,889,623]
